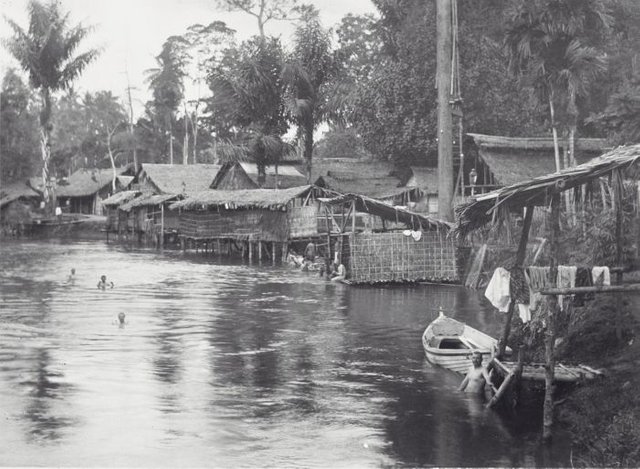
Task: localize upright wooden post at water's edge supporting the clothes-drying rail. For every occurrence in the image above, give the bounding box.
[542,194,560,442]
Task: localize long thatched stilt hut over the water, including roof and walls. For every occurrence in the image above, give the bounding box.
[171,185,325,260]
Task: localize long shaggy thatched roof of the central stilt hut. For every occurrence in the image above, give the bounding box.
[169,186,313,210]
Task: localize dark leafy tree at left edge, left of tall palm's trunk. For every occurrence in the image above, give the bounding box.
[0,69,39,183]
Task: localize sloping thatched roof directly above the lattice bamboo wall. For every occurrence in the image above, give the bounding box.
[320,194,453,231]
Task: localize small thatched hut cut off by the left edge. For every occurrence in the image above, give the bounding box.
[0,181,41,236]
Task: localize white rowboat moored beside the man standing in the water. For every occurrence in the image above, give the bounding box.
[422,311,511,374]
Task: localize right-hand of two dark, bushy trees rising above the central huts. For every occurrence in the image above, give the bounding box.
[283,12,335,182]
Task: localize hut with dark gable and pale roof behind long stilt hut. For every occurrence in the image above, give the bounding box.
[211,162,307,190]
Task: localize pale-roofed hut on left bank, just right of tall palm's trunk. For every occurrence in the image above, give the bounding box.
[55,167,131,215]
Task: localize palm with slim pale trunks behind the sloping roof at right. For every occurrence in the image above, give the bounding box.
[505,0,611,171]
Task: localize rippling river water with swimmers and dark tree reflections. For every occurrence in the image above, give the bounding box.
[0,242,569,467]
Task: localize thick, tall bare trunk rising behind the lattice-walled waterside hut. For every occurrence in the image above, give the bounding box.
[436,0,453,221]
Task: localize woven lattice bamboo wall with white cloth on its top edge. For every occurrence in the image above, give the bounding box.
[348,230,460,283]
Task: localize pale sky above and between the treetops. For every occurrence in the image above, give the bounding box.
[0,0,376,117]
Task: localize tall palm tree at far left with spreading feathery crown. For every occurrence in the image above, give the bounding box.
[5,0,98,211]
